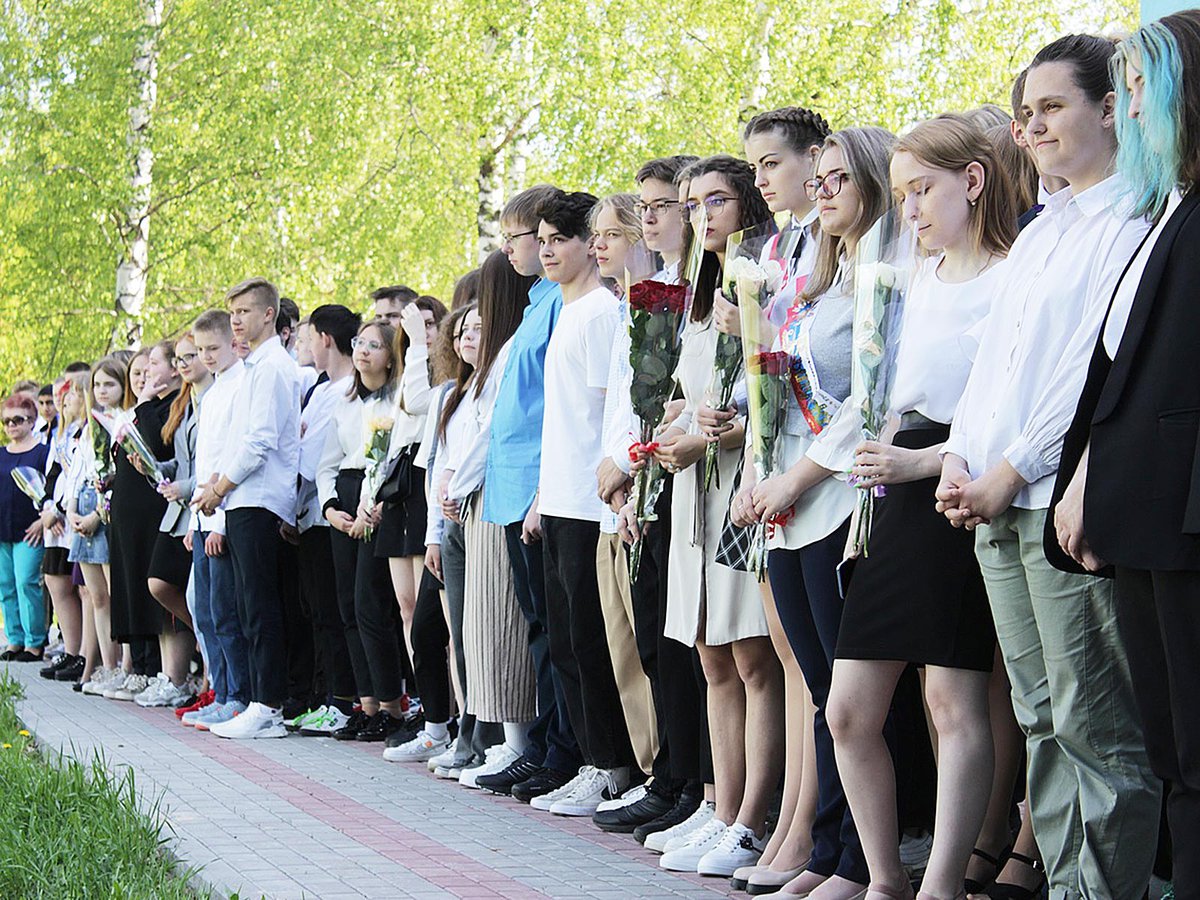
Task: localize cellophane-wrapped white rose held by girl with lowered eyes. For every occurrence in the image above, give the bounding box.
[845,210,917,559]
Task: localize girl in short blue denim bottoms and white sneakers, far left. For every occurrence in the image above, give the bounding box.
[67,355,127,695]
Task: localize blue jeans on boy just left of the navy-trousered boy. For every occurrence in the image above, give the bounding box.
[192,532,250,703]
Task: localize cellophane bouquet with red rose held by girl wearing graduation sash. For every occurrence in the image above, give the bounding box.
[739,250,794,581]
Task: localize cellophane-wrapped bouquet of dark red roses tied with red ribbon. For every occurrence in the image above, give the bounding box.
[625,224,707,581]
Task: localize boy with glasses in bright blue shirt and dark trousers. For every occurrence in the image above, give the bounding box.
[448,185,580,803]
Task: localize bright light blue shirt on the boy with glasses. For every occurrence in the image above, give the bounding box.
[484,278,563,526]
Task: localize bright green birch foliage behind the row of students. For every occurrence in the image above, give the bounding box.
[0,0,1135,384]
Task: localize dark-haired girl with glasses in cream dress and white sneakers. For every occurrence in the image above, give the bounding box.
[655,156,784,877]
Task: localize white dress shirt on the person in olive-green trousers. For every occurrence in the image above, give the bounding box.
[942,175,1150,509]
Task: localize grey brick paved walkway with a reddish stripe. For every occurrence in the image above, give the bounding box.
[10,665,731,900]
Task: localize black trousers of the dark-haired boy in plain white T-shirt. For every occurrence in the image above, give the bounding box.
[541,516,637,769]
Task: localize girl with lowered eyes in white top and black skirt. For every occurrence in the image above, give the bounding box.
[828,115,1018,898]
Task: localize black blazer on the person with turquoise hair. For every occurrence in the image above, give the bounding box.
[1044,191,1200,572]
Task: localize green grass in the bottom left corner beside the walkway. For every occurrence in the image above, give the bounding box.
[0,672,204,900]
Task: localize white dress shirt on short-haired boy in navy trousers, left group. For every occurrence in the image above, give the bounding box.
[222,335,300,523]
